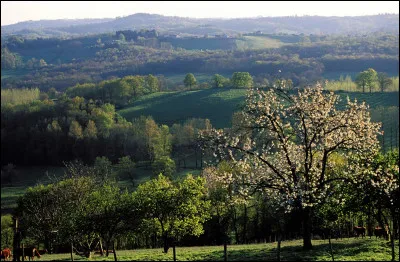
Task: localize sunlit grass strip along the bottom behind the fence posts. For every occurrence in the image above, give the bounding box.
[11,238,398,261]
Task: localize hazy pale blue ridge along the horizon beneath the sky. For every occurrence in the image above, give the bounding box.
[1,13,399,36]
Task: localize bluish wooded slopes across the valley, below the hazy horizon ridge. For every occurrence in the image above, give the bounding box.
[2,33,398,90]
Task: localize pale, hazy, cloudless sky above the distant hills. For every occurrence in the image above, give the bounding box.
[1,1,399,25]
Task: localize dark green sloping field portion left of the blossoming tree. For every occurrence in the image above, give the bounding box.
[118,89,246,128]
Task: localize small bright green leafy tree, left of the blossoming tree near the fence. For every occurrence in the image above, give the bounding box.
[133,174,210,253]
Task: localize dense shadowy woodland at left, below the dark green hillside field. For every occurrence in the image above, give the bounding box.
[1,94,211,168]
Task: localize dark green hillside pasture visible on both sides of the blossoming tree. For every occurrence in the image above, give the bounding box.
[118,88,399,150]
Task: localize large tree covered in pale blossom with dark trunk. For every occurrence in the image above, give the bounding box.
[200,85,380,249]
